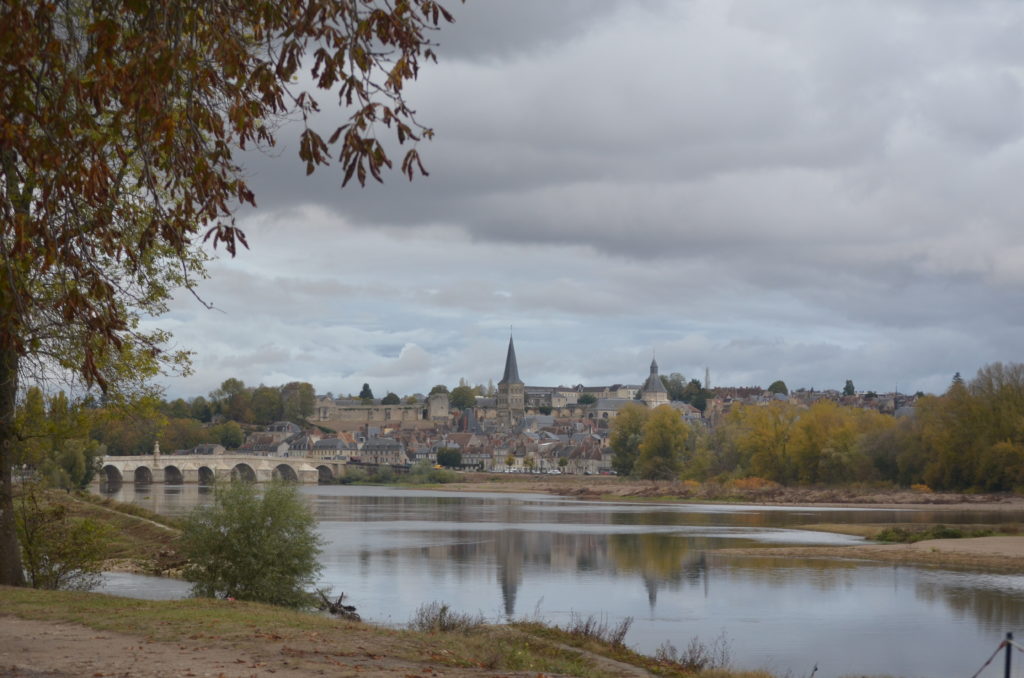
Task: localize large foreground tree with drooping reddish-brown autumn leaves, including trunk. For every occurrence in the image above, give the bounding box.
[0,0,451,585]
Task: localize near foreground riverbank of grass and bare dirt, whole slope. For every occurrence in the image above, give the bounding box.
[0,587,769,678]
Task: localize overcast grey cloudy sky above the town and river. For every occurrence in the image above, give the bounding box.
[154,0,1024,397]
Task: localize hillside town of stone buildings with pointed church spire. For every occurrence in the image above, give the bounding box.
[159,337,918,474]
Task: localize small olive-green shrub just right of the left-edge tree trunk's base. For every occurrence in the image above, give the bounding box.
[14,483,110,591]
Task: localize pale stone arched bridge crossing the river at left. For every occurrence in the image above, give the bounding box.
[99,454,345,484]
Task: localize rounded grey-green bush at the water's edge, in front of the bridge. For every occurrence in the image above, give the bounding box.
[181,481,321,607]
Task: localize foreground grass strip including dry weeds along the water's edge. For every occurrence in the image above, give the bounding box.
[0,587,770,678]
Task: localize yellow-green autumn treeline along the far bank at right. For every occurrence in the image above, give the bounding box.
[610,363,1024,492]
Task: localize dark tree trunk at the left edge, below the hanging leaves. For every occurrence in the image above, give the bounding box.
[0,346,25,586]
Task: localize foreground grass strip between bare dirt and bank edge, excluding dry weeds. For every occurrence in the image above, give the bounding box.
[0,587,611,678]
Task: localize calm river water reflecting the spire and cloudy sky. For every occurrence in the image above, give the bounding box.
[96,484,1024,678]
